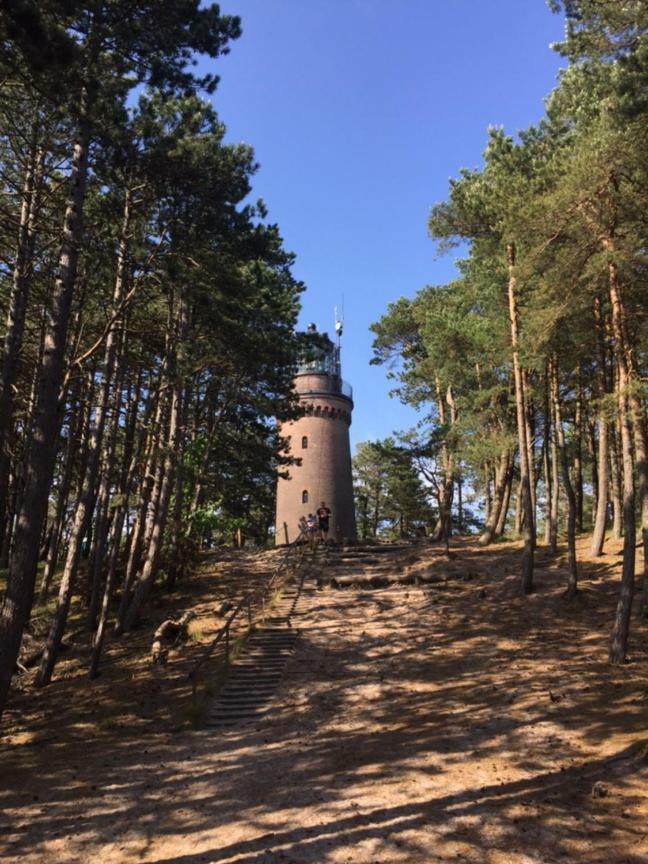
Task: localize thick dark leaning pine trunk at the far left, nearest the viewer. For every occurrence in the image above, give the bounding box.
[0,96,90,713]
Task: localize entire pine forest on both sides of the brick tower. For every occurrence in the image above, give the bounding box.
[0,0,648,724]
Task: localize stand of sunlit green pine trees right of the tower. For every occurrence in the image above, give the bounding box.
[370,0,648,663]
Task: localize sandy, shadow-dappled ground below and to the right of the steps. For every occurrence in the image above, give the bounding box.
[0,544,648,864]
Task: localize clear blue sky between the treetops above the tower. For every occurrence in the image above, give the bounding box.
[214,0,563,452]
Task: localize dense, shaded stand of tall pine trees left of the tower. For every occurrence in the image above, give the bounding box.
[0,0,301,711]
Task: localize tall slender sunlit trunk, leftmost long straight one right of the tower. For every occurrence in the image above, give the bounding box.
[506,243,535,594]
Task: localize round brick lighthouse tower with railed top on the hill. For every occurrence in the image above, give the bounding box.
[276,324,356,544]
